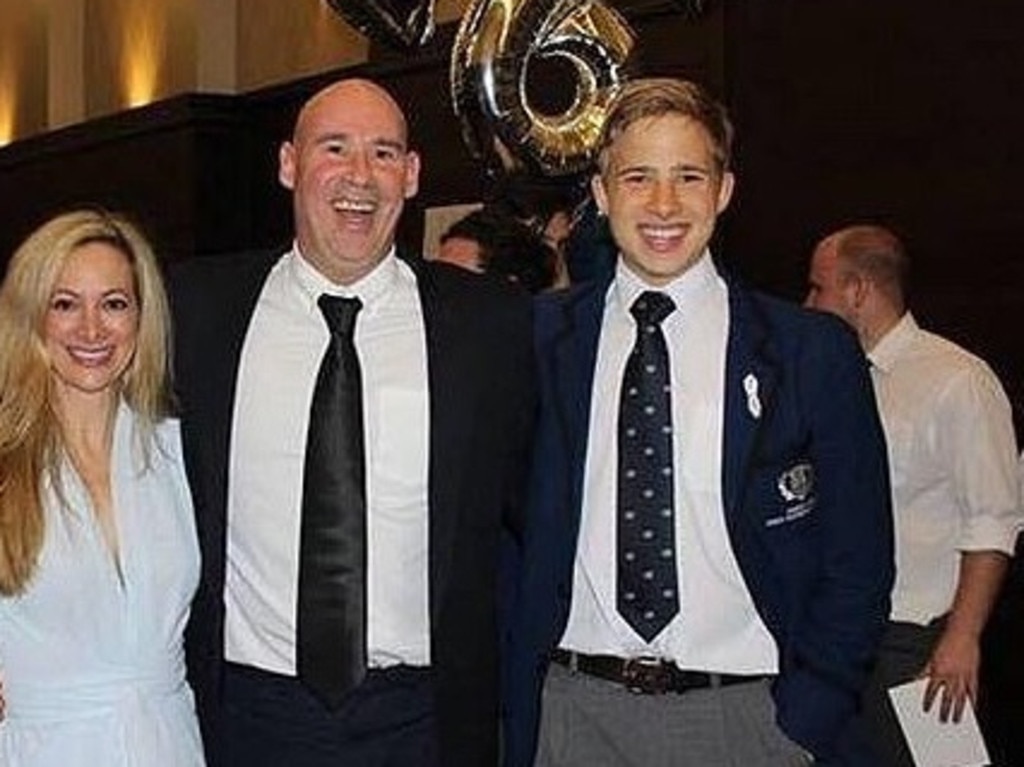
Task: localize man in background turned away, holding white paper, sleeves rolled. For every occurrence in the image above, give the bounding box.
[806,225,1022,765]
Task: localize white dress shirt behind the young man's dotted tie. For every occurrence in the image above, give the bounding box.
[561,253,778,674]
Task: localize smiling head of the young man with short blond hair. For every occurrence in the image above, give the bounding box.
[591,79,734,286]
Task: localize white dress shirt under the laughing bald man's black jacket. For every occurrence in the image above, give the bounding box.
[224,248,430,675]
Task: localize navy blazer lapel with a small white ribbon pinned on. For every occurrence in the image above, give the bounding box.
[722,280,779,516]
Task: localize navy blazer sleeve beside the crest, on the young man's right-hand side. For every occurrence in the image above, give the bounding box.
[776,324,894,757]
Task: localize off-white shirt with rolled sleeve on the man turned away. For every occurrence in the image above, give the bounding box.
[868,312,1022,624]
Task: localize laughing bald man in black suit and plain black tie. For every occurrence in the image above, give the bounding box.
[174,80,532,767]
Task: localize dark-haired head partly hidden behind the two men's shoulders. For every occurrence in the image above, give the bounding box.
[432,207,555,293]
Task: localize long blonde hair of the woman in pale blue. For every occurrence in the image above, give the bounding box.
[0,210,170,595]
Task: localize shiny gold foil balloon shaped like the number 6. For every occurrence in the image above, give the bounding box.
[451,0,634,175]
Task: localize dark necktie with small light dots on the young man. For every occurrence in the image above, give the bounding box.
[615,291,679,642]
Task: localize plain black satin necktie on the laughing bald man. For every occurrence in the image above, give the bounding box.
[296,295,367,708]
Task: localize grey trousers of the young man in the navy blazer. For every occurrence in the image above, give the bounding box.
[536,664,812,767]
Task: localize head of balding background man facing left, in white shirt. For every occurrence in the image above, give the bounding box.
[804,224,909,351]
